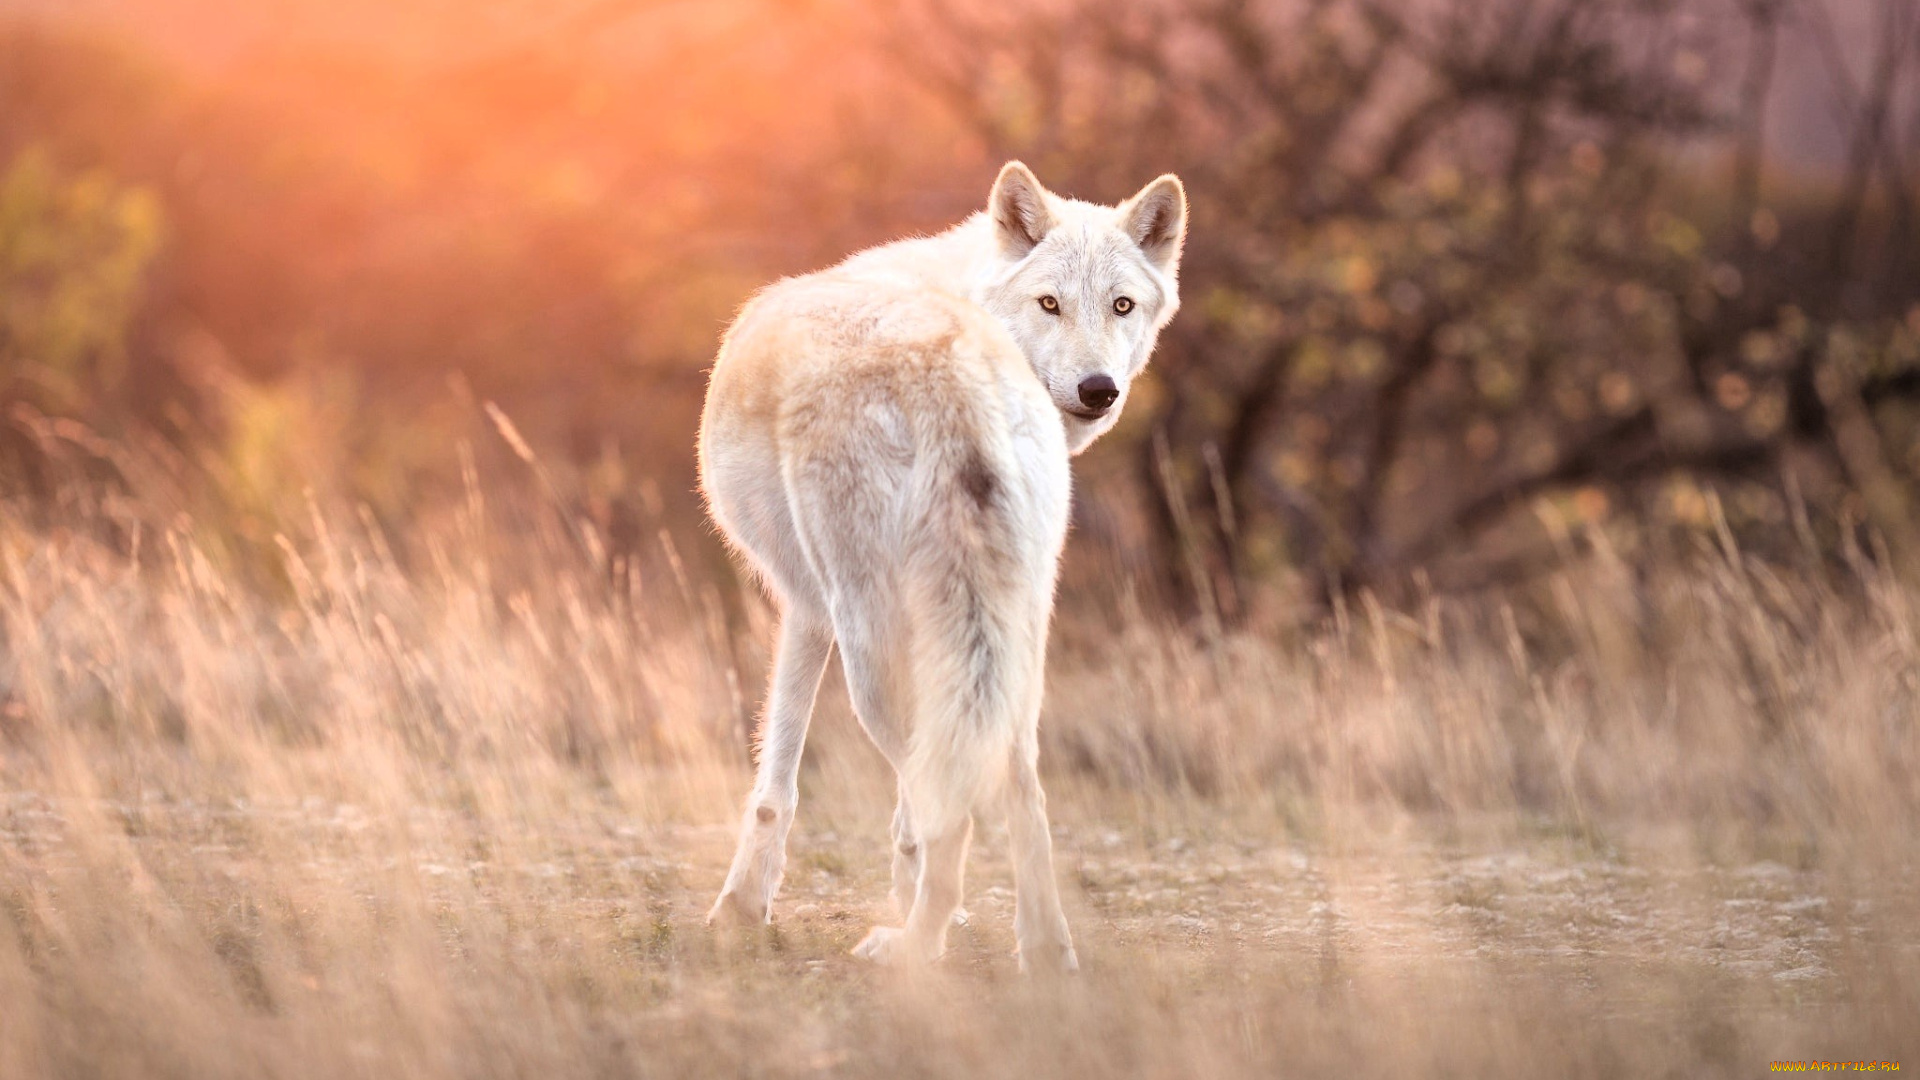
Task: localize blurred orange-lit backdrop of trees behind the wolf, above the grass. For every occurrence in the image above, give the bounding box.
[0,0,1920,619]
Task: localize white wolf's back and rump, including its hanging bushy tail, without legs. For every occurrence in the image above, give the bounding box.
[710,273,1068,836]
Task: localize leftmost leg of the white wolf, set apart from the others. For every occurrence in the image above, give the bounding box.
[707,609,833,926]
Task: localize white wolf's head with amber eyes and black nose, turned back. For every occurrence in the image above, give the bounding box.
[981,161,1187,454]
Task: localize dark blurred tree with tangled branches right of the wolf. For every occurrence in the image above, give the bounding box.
[889,0,1920,617]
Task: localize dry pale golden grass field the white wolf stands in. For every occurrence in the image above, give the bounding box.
[0,480,1920,1080]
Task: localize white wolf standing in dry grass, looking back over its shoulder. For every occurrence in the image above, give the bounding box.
[699,161,1187,969]
